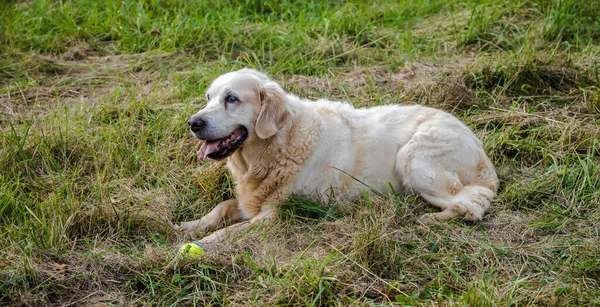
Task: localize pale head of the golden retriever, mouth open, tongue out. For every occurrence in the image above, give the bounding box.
[188,68,289,160]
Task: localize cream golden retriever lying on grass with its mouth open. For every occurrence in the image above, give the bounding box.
[175,68,499,243]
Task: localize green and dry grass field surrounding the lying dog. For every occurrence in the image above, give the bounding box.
[0,0,600,306]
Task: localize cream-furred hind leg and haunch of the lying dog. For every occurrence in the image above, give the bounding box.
[397,130,498,221]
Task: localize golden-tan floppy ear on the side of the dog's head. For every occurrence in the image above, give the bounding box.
[255,81,290,140]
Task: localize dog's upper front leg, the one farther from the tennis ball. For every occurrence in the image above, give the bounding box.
[173,198,242,231]
